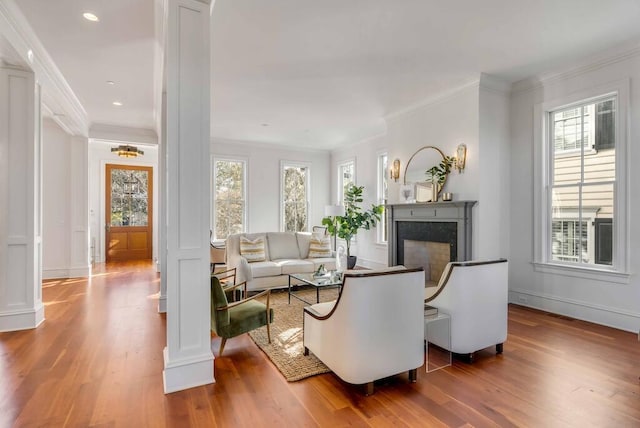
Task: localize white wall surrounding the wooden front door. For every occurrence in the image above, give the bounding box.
[89,140,159,263]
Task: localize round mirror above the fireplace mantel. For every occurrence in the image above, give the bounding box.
[404,146,447,202]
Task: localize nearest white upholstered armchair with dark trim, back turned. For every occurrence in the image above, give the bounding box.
[304,268,424,395]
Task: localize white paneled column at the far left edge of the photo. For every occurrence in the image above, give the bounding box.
[0,68,44,331]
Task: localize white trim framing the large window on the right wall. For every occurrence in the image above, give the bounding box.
[532,78,631,283]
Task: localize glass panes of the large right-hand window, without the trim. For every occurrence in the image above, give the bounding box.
[549,97,616,265]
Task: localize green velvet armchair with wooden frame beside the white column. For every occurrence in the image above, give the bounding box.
[211,275,273,356]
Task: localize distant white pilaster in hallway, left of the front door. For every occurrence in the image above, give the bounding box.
[69,137,91,278]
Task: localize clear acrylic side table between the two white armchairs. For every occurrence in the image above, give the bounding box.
[424,312,451,373]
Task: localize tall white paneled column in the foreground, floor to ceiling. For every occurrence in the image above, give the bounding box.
[164,0,214,393]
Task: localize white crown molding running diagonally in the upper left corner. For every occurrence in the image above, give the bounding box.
[0,0,89,136]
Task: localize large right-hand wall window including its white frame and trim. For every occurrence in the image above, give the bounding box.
[533,79,630,283]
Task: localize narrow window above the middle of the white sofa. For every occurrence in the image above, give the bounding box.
[281,162,310,232]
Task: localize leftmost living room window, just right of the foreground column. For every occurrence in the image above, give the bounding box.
[212,158,246,240]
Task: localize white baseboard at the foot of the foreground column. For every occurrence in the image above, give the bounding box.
[162,348,216,394]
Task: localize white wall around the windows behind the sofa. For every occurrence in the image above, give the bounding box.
[211,139,330,232]
